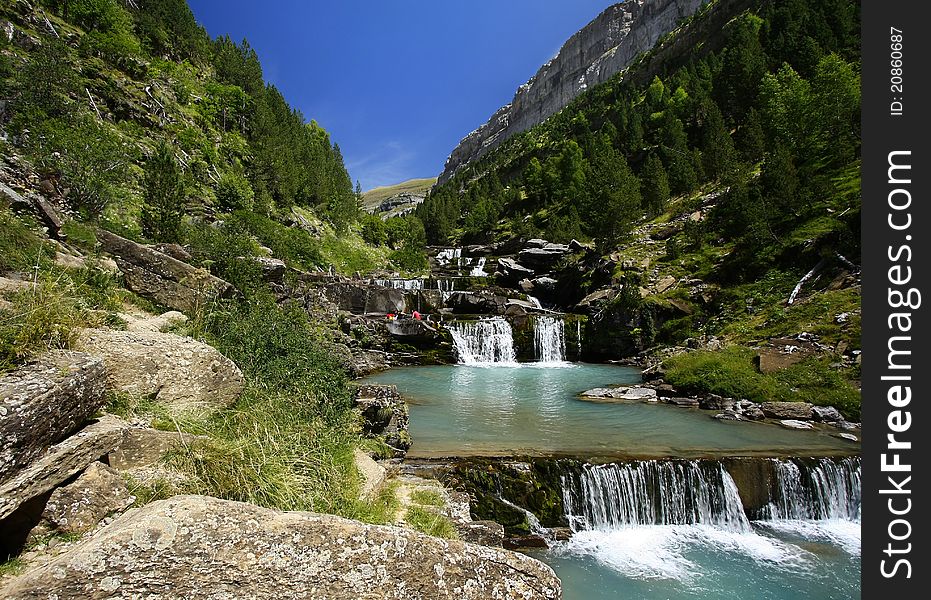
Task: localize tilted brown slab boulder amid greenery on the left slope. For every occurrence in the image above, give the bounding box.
[97,229,236,313]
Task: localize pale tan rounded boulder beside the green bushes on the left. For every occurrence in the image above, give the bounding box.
[75,329,244,414]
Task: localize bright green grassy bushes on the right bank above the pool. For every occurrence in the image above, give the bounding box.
[664,346,860,421]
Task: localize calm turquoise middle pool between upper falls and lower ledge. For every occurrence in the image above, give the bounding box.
[365,363,859,458]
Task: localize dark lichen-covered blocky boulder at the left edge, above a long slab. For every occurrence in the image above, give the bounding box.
[0,350,107,481]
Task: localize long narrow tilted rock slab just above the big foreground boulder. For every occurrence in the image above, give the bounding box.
[0,416,128,520]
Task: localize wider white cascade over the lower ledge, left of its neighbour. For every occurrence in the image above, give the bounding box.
[562,460,750,531]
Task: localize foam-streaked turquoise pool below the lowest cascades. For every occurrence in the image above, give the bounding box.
[530,521,860,600]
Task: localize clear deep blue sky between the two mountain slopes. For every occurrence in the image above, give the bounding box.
[189,0,612,189]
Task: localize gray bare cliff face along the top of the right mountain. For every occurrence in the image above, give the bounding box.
[439,0,703,183]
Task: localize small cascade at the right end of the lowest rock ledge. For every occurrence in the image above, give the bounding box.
[760,457,861,521]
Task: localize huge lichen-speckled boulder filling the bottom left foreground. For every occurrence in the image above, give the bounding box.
[0,496,561,600]
